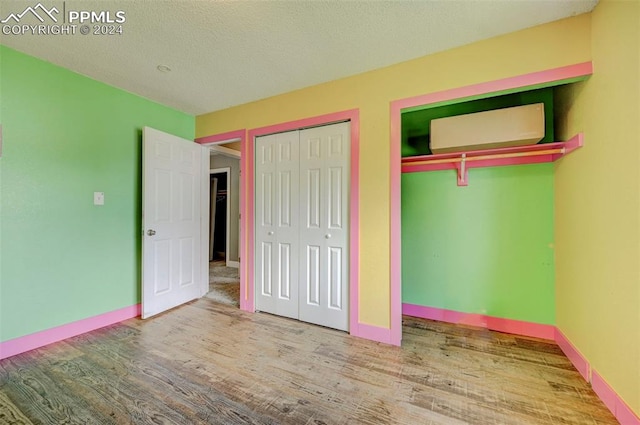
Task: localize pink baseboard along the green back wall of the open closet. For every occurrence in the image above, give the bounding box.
[402,304,555,340]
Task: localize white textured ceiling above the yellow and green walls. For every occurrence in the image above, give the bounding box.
[0,0,597,115]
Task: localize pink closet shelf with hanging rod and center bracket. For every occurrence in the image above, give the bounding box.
[402,133,584,186]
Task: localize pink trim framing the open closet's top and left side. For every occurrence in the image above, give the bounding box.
[389,62,593,345]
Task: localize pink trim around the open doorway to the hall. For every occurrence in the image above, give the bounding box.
[195,128,253,311]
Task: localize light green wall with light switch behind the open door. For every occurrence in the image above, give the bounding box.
[0,46,195,341]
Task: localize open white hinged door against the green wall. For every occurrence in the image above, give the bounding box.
[142,127,208,319]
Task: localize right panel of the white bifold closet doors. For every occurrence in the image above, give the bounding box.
[299,122,351,330]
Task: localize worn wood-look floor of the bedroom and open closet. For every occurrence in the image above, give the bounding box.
[0,298,617,425]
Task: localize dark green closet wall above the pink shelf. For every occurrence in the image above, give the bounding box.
[401,87,556,156]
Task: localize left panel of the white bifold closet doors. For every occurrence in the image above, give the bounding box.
[254,131,299,319]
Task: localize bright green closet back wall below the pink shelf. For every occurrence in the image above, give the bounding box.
[402,164,555,325]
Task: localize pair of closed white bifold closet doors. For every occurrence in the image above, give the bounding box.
[255,122,351,330]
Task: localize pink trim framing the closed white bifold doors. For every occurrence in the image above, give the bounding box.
[245,109,361,336]
